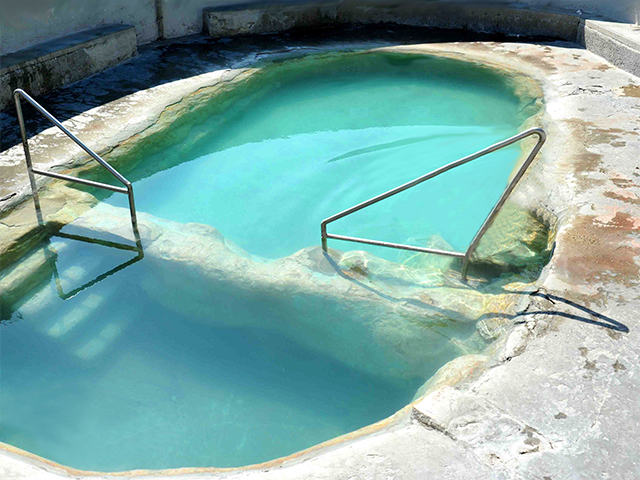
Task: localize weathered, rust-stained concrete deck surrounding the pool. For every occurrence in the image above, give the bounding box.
[0,27,640,480]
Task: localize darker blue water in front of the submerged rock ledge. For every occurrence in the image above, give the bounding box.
[0,240,439,471]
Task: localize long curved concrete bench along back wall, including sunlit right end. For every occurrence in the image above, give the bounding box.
[203,0,640,76]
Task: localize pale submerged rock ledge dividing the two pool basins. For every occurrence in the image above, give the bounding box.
[3,205,540,380]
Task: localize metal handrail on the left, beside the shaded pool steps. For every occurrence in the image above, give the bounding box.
[13,88,138,232]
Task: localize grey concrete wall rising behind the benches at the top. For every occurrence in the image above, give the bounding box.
[0,0,640,55]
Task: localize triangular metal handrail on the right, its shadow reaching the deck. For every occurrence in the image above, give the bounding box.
[320,128,547,281]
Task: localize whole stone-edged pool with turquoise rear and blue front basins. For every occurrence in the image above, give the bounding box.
[0,53,544,471]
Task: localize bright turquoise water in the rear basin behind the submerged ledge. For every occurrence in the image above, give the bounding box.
[102,53,523,260]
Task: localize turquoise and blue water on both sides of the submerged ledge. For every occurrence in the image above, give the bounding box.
[0,54,522,471]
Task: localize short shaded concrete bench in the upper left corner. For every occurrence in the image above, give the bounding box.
[0,25,137,110]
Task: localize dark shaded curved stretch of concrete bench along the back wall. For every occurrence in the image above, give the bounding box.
[203,0,580,41]
